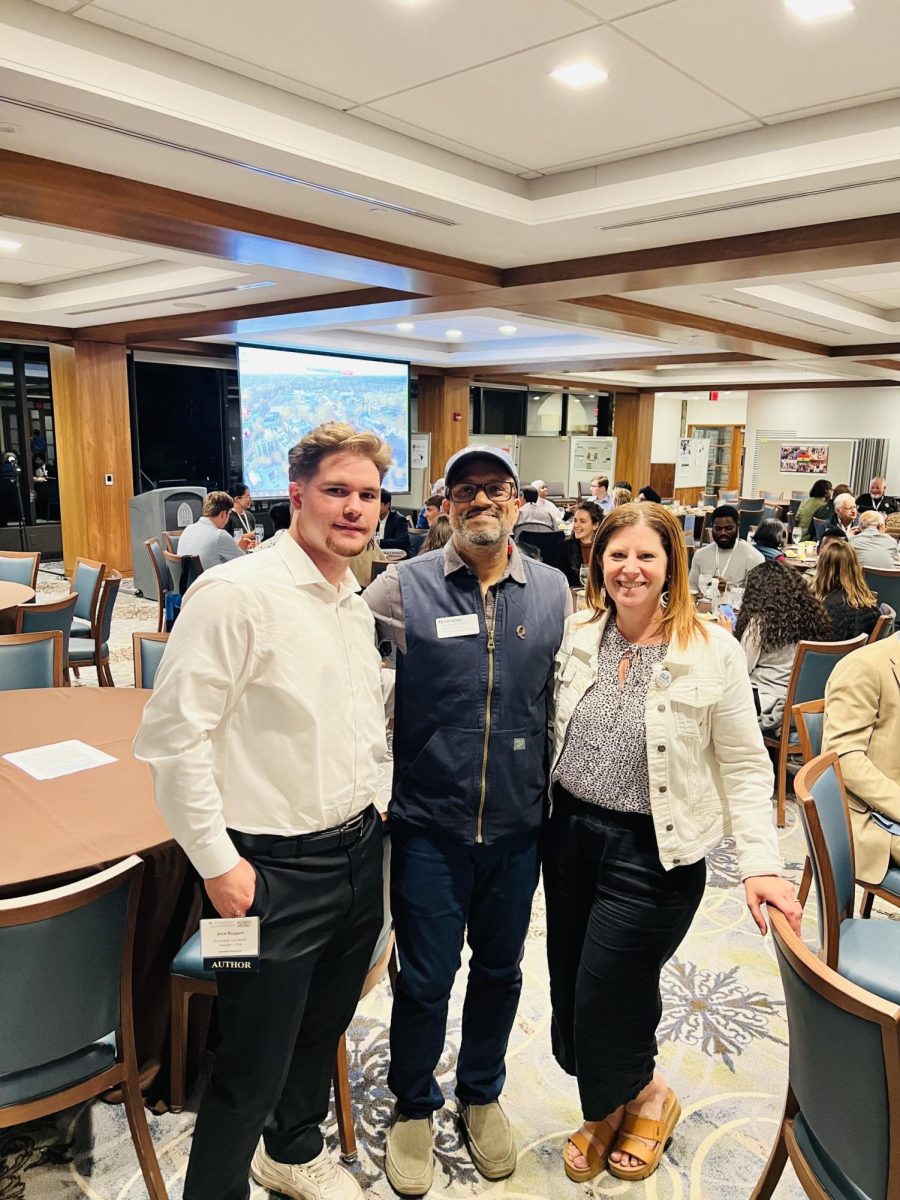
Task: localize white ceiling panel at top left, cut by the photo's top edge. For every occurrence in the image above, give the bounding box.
[79,0,594,103]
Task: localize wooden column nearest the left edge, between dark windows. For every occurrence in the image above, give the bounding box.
[50,342,133,575]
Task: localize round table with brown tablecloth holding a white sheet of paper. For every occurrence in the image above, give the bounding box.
[0,691,199,1098]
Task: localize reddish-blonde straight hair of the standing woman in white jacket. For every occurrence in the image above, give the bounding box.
[584,500,708,646]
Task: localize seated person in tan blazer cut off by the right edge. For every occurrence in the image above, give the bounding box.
[822,635,900,883]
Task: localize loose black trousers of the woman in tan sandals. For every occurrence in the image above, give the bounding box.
[544,784,706,1121]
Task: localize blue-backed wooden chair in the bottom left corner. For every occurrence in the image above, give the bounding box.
[0,854,168,1200]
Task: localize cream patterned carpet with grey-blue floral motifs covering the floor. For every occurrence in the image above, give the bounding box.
[0,578,878,1200]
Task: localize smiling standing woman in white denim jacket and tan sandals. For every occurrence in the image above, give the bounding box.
[544,503,800,1182]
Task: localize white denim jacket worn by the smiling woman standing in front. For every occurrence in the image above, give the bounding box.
[551,612,782,880]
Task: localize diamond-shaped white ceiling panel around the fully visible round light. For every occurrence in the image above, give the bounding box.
[371,28,744,170]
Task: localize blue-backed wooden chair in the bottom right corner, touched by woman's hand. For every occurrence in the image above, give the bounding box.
[750,908,900,1200]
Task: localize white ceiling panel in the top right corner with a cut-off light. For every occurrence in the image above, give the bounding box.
[616,0,900,116]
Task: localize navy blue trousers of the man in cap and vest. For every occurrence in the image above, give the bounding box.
[388,821,540,1117]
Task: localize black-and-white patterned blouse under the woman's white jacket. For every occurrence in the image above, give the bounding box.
[553,619,668,815]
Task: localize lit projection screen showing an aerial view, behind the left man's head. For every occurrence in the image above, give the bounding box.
[238,346,409,498]
